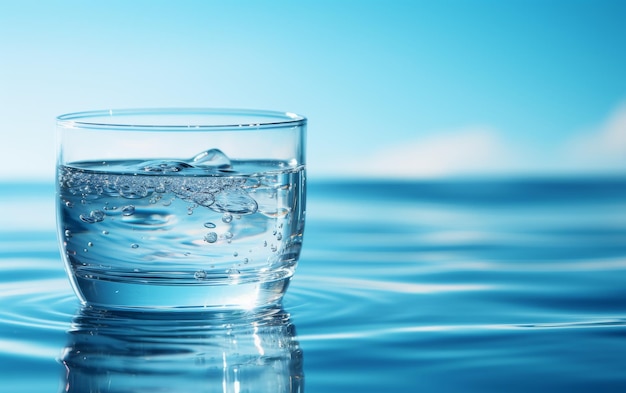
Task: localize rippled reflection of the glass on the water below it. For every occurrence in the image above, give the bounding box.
[61,307,304,393]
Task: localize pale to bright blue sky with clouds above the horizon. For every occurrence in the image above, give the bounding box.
[0,0,626,180]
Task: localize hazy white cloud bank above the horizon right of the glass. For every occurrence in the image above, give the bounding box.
[324,102,626,178]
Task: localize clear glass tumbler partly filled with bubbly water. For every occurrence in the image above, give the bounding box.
[57,109,306,310]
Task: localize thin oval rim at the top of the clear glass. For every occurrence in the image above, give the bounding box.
[56,108,307,131]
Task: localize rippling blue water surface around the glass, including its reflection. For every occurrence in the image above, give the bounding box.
[0,178,626,392]
